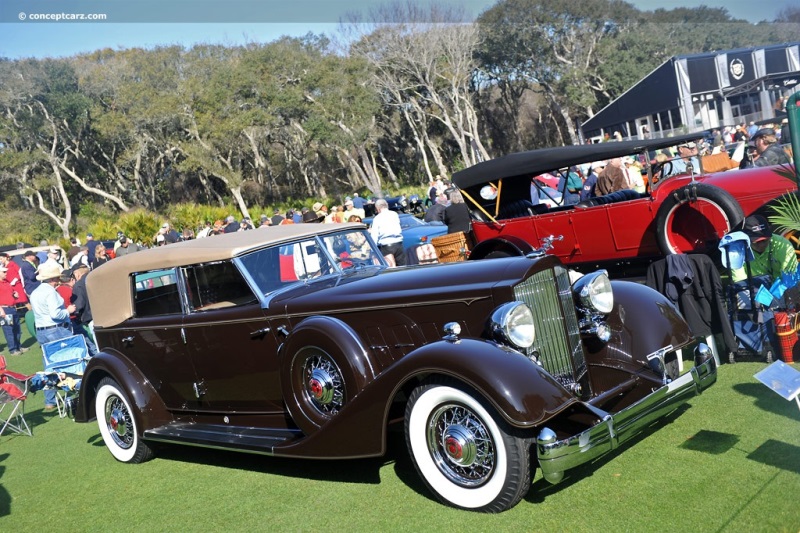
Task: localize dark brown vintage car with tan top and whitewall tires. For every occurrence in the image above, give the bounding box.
[76,224,716,511]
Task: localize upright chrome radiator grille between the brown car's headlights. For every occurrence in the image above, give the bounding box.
[514,266,586,390]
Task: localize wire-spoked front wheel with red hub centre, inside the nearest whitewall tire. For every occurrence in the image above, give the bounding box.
[427,404,496,487]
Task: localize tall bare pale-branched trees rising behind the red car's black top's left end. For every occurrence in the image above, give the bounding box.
[351,4,488,179]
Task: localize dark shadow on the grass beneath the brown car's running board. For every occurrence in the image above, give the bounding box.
[87,424,413,485]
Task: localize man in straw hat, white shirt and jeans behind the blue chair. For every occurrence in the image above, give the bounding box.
[30,261,75,411]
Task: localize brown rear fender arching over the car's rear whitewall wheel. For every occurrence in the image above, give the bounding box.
[75,350,171,428]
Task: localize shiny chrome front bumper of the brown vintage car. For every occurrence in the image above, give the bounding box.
[536,348,717,483]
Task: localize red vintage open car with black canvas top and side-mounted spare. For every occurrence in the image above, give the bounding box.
[453,133,797,276]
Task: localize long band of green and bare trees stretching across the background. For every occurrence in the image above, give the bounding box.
[0,0,798,237]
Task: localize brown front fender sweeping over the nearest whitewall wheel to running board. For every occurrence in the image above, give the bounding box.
[275,339,578,458]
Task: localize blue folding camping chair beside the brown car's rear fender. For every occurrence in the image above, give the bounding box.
[42,335,89,418]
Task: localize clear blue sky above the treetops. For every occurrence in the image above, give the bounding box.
[0,0,795,59]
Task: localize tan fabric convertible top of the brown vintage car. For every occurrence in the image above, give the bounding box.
[86,223,364,327]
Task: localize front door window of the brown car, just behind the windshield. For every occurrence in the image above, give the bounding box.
[183,261,258,311]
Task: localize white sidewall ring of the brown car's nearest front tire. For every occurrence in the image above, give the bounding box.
[406,385,509,509]
